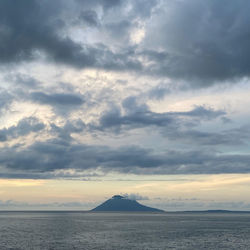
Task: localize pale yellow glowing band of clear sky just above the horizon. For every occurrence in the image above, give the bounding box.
[0,174,250,211]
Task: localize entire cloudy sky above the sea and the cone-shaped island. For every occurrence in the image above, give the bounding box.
[0,0,250,211]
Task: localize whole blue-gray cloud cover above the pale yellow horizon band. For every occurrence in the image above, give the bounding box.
[0,0,250,182]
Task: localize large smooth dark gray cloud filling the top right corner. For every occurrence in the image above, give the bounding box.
[144,0,250,85]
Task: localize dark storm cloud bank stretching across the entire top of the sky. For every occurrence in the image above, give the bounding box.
[0,0,250,83]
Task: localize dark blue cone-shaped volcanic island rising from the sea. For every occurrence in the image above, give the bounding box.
[91,195,164,212]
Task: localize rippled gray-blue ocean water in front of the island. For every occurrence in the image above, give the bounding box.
[0,212,250,250]
